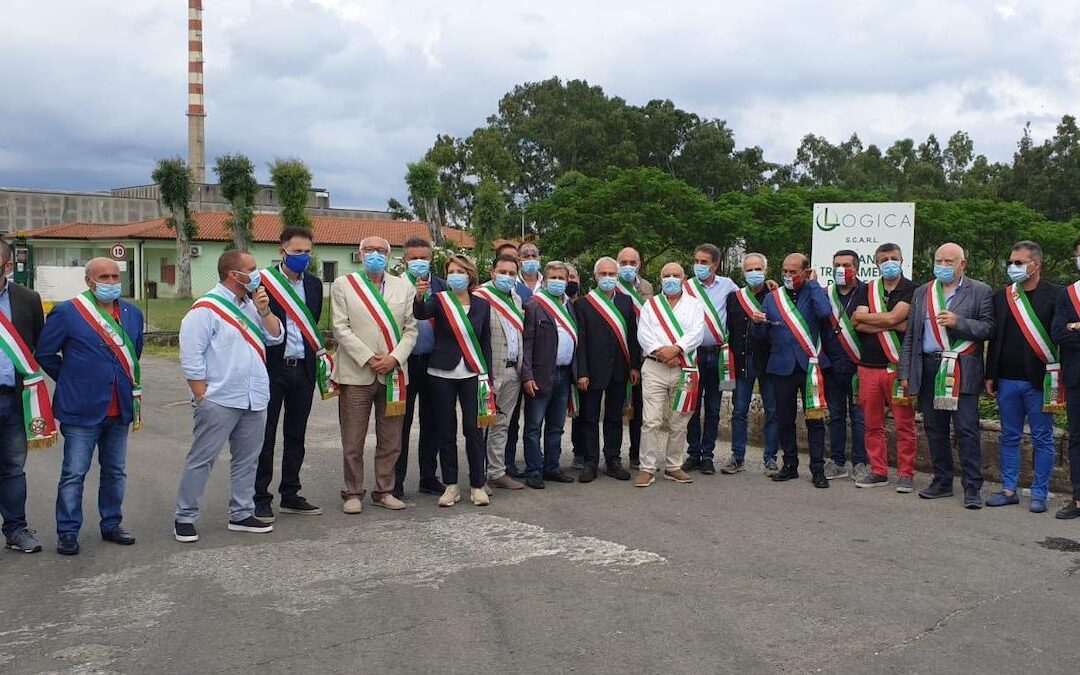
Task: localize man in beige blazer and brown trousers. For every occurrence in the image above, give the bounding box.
[330,237,417,513]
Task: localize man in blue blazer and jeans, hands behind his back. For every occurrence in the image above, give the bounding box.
[35,258,143,555]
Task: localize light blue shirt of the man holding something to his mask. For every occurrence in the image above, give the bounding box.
[180,284,285,410]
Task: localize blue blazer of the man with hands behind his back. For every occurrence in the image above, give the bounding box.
[35,300,143,427]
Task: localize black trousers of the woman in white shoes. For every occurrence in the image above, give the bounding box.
[428,375,487,487]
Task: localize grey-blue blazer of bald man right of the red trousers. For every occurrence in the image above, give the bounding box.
[900,276,994,396]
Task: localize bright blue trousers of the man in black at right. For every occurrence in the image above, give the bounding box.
[997,380,1054,499]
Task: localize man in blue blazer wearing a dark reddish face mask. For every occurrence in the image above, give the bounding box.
[752,253,833,488]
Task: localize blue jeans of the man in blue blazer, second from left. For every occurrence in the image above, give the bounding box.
[56,417,127,535]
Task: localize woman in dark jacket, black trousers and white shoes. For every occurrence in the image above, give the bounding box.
[416,255,497,507]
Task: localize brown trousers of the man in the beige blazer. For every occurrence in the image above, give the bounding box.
[338,380,404,499]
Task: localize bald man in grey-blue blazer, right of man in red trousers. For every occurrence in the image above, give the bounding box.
[900,243,994,509]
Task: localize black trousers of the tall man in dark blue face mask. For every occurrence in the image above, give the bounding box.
[255,362,315,504]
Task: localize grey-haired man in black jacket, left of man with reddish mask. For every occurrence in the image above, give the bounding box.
[720,253,780,477]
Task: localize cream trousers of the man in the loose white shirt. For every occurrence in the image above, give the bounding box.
[640,359,690,473]
